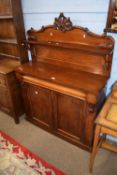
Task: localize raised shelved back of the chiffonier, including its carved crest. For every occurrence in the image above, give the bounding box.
[27,13,114,77]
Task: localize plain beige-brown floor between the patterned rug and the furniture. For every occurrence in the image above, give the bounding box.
[0,112,117,175]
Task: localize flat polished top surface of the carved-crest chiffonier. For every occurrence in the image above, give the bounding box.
[17,62,107,95]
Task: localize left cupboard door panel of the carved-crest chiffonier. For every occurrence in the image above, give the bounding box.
[29,85,53,128]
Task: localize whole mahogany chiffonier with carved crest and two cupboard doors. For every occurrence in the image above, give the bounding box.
[16,13,114,151]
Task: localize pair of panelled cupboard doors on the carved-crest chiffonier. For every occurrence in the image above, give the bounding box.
[22,83,85,143]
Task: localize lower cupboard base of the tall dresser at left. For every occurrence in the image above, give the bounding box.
[0,60,23,123]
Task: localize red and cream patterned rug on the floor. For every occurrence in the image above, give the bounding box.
[0,131,64,175]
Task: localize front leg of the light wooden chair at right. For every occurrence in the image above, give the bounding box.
[89,126,100,173]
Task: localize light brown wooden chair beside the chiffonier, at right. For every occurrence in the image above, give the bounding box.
[89,82,117,172]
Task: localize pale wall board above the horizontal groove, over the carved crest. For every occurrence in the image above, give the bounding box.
[22,0,109,13]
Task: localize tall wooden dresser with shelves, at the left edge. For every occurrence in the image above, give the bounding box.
[0,0,28,123]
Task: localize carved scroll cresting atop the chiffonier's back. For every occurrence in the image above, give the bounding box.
[53,13,73,32]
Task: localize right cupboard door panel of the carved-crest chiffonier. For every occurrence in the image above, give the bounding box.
[56,94,84,141]
